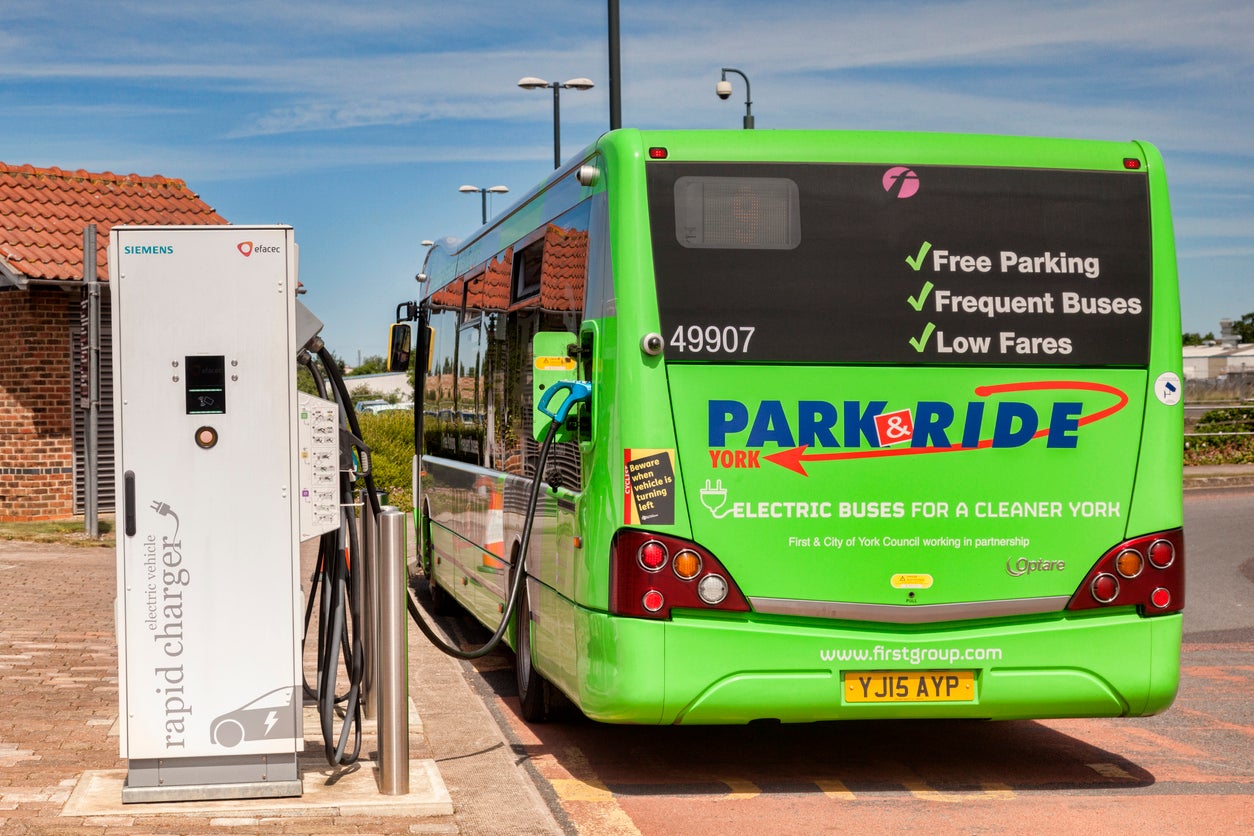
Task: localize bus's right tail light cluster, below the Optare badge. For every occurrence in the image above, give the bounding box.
[1067,529,1184,615]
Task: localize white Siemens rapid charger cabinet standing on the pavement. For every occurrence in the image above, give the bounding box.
[109,226,318,802]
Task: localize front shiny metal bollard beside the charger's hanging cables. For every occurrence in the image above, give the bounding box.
[376,505,409,796]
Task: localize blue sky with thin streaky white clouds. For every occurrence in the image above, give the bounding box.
[0,0,1254,363]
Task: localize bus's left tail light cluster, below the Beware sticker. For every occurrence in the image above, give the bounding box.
[609,529,749,618]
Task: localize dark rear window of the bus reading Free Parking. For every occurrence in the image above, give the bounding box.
[646,162,1152,366]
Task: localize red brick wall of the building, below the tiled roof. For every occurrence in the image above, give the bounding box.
[0,287,78,521]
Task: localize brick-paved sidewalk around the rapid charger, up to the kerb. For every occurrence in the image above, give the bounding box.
[0,540,561,835]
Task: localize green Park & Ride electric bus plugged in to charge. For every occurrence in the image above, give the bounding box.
[415,129,1184,723]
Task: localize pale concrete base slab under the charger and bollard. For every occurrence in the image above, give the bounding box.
[60,758,453,817]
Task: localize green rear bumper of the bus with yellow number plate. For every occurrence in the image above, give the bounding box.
[579,610,1181,724]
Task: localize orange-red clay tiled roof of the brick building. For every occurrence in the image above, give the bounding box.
[0,163,227,281]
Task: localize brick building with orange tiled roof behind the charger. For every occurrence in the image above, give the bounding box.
[0,163,226,521]
